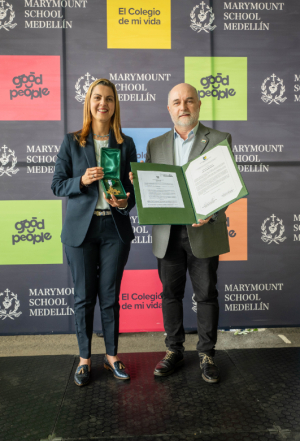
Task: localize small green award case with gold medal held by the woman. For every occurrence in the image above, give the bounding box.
[100,148,127,199]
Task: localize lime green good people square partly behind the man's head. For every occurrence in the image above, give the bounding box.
[184,57,247,121]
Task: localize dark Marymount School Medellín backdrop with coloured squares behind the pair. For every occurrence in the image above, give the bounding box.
[0,0,300,334]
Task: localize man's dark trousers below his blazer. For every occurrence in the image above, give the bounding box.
[158,225,219,356]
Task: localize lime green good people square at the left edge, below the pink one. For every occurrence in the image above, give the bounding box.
[0,200,63,265]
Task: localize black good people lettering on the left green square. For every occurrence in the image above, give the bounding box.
[12,217,52,245]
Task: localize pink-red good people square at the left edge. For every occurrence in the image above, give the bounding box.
[0,55,61,121]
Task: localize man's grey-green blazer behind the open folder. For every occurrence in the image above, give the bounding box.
[146,123,231,258]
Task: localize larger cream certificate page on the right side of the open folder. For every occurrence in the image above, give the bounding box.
[185,145,242,215]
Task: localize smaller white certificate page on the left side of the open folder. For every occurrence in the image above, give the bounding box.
[137,170,184,208]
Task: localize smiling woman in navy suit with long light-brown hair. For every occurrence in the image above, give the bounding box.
[51,79,137,386]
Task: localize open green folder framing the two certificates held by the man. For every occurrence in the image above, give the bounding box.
[131,140,248,225]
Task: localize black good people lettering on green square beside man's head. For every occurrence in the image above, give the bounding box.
[198,73,236,100]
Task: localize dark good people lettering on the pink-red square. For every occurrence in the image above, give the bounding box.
[10,72,50,100]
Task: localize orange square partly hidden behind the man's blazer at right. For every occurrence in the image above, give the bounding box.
[220,199,248,261]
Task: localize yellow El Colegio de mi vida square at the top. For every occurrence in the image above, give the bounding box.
[107,0,171,49]
